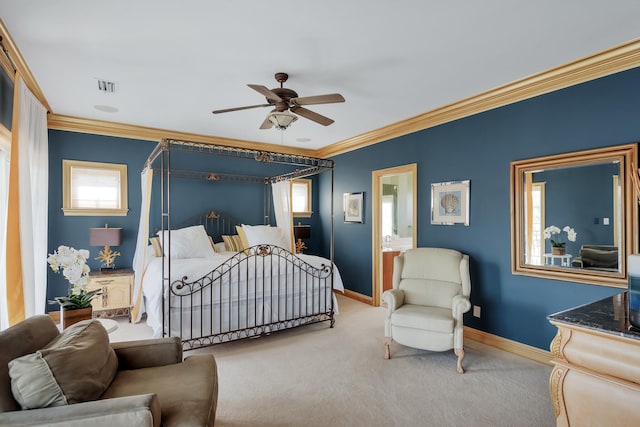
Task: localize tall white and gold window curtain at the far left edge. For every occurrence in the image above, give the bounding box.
[6,76,49,325]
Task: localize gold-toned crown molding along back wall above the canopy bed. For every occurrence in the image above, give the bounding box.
[47,114,315,157]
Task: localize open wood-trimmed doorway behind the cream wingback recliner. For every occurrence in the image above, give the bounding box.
[371,163,418,306]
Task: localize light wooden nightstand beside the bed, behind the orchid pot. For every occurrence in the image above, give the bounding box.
[87,268,133,321]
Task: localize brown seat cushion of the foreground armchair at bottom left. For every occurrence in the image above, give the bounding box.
[101,354,218,427]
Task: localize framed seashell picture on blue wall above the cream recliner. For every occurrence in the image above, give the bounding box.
[431,180,470,226]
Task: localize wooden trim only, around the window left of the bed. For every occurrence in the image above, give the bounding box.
[62,159,129,216]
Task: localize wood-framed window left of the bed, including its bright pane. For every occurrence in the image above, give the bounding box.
[62,160,128,216]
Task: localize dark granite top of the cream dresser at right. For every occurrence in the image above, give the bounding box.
[547,292,640,341]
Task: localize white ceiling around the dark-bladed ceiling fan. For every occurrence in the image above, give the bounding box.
[0,0,640,148]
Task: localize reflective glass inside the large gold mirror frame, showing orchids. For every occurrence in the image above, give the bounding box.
[523,160,621,273]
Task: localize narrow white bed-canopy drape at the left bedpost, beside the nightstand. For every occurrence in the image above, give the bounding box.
[131,167,153,322]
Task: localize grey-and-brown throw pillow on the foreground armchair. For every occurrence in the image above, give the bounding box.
[9,320,118,409]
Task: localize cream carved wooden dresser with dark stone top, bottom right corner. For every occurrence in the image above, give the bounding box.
[548,292,640,427]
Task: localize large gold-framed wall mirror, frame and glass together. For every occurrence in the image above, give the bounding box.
[511,143,638,288]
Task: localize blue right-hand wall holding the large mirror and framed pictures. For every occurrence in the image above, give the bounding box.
[320,69,640,349]
